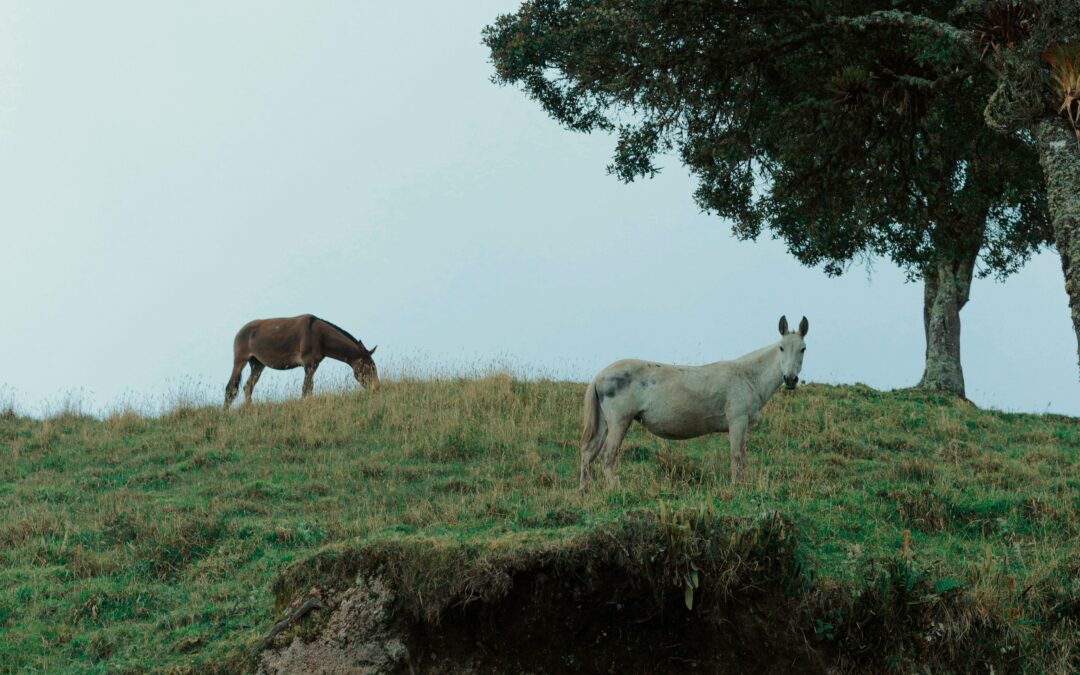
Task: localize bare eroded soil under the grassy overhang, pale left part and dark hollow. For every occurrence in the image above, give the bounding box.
[258,566,826,674]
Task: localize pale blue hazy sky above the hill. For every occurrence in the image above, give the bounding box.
[0,0,1080,415]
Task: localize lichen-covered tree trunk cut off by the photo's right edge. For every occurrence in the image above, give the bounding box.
[1036,119,1080,375]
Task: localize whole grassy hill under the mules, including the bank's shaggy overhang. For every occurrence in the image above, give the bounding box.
[0,376,1080,672]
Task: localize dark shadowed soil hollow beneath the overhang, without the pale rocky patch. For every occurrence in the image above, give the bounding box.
[403,568,825,674]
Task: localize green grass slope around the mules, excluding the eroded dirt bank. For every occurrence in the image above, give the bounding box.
[0,376,1080,672]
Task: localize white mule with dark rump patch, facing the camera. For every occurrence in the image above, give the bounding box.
[580,316,810,489]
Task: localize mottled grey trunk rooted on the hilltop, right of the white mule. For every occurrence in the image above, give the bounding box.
[918,246,978,396]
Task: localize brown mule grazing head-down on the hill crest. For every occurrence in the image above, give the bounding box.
[225,314,379,408]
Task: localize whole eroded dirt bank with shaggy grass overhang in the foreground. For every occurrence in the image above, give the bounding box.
[256,511,1017,674]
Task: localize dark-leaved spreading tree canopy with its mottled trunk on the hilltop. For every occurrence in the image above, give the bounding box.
[485,0,1080,384]
